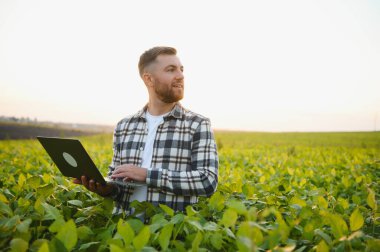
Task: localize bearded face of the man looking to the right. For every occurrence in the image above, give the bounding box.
[150,55,184,103]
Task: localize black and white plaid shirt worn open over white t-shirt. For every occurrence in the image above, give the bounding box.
[108,103,218,213]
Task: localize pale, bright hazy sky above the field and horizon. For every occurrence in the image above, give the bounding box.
[0,0,380,132]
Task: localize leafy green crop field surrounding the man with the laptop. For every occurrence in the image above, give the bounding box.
[0,131,380,252]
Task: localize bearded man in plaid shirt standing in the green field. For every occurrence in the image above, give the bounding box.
[74,47,218,213]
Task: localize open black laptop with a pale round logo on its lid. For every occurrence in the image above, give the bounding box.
[37,136,145,186]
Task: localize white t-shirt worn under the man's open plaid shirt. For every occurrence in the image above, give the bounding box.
[130,110,167,205]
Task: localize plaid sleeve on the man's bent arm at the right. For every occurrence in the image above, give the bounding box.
[146,119,218,197]
